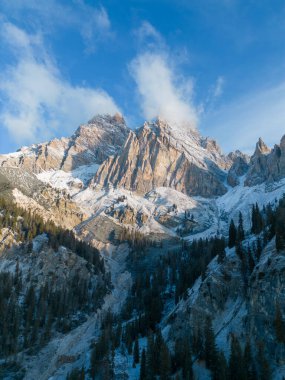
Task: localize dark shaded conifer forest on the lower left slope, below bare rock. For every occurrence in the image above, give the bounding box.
[0,272,105,357]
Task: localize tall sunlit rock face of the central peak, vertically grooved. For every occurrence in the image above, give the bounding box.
[92,119,227,197]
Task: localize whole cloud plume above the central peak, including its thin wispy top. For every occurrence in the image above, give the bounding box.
[129,21,197,129]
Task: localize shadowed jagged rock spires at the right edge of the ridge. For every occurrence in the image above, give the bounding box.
[245,135,285,186]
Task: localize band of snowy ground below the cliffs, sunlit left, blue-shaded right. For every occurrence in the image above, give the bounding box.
[38,160,285,240]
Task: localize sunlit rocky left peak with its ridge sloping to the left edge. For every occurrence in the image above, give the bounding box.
[0,114,129,173]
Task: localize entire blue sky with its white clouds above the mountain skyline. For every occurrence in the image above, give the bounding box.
[0,0,285,153]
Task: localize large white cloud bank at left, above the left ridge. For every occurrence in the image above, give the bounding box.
[0,23,119,143]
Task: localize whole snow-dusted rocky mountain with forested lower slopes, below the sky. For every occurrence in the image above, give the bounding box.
[0,115,285,380]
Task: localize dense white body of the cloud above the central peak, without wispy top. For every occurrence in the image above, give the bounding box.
[130,53,197,128]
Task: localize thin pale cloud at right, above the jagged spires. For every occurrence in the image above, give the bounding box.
[201,82,285,153]
